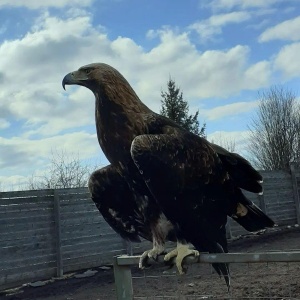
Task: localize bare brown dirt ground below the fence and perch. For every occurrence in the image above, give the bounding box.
[0,227,300,300]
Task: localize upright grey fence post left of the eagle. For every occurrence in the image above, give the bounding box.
[53,189,64,277]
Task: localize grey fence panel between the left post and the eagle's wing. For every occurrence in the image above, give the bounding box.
[57,189,125,272]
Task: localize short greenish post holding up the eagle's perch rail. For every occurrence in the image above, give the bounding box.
[114,256,133,300]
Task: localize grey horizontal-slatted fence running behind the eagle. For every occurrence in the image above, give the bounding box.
[0,166,300,290]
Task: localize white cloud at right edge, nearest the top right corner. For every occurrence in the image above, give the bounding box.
[259,17,300,42]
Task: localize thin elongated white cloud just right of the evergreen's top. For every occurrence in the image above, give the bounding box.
[199,101,258,121]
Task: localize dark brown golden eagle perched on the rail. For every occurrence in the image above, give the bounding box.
[62,63,274,286]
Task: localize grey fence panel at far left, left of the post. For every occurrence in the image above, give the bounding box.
[0,191,56,288]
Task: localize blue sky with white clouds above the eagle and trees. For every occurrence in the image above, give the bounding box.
[0,0,300,190]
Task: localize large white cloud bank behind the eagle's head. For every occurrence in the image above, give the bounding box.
[0,14,271,192]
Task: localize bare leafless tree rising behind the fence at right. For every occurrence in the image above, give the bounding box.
[249,87,300,170]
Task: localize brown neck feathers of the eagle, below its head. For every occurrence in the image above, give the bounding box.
[93,78,152,164]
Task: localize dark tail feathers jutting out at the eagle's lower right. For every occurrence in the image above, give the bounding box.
[232,202,275,232]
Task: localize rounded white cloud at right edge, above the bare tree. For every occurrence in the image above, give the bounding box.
[274,43,300,79]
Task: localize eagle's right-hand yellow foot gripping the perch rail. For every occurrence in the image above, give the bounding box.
[164,243,200,274]
